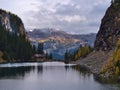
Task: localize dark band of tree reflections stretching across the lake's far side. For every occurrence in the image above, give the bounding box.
[0,65,90,79]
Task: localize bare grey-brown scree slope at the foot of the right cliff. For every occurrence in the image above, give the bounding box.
[71,50,113,75]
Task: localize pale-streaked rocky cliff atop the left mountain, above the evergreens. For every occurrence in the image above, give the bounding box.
[0,9,26,37]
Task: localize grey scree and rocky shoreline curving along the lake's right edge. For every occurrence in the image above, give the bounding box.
[71,50,120,84]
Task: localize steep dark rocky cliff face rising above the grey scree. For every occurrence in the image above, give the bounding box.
[94,0,120,51]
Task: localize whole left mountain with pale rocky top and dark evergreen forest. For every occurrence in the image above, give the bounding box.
[0,9,33,62]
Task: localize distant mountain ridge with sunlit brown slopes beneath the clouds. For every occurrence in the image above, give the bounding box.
[28,28,96,47]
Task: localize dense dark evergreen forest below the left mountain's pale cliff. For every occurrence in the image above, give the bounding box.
[0,26,34,61]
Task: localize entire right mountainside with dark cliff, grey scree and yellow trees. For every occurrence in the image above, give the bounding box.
[72,0,120,83]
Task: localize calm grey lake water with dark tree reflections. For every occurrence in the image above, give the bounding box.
[0,62,120,90]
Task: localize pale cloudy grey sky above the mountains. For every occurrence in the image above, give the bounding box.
[0,0,111,34]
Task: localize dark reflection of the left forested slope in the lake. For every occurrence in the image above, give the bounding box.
[0,66,43,79]
